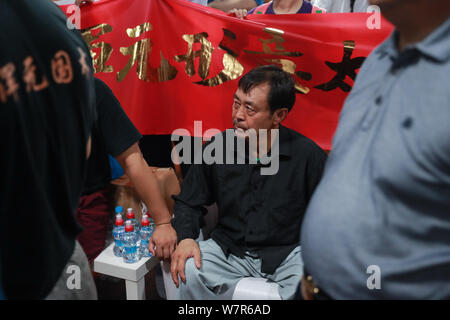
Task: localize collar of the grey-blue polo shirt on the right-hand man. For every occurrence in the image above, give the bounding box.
[374,18,450,62]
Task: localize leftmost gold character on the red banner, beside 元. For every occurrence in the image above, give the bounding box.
[81,23,114,73]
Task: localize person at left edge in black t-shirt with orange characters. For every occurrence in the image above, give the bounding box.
[0,0,96,299]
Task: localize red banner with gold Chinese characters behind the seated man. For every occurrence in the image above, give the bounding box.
[62,0,392,149]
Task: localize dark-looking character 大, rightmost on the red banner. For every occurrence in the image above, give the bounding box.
[315,40,366,92]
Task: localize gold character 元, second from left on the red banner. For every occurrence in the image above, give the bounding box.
[117,22,178,83]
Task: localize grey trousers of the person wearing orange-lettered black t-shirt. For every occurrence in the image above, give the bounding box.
[45,241,97,300]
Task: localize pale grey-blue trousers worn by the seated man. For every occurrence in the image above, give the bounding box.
[176,239,303,300]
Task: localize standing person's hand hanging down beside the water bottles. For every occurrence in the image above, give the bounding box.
[148,223,178,260]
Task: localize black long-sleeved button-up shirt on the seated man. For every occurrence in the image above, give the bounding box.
[172,126,326,273]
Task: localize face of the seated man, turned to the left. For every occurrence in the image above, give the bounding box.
[232,83,278,137]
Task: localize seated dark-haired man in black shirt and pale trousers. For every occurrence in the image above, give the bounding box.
[171,66,326,299]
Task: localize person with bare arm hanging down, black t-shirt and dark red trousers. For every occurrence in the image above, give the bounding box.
[76,78,177,262]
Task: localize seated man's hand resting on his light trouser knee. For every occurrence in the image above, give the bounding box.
[170,239,202,288]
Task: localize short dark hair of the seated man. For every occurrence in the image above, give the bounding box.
[239,65,295,113]
